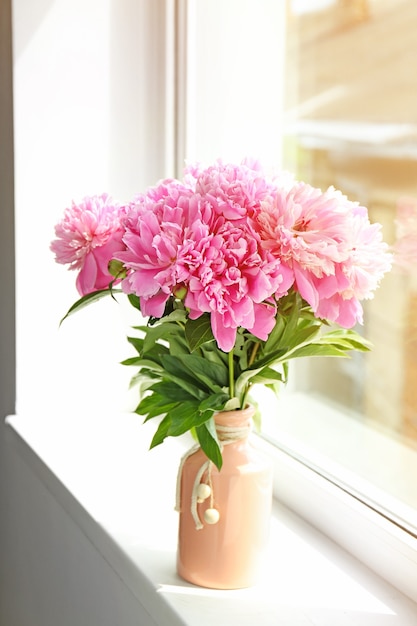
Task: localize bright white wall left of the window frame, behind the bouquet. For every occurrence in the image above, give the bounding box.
[13,0,172,419]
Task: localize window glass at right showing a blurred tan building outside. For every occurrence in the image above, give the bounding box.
[284,0,417,528]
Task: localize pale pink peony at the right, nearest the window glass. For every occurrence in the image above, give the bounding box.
[256,183,391,328]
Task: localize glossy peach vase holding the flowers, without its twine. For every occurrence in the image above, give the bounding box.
[177,407,272,589]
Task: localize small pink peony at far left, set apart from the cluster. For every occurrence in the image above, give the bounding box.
[50,194,125,296]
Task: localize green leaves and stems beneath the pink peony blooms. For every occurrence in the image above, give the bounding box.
[63,288,371,468]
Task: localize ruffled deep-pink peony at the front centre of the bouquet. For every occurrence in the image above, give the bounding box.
[178,220,293,352]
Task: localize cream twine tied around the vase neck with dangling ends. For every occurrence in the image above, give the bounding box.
[175,416,251,530]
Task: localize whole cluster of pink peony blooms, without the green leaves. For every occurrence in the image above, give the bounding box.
[51,160,391,352]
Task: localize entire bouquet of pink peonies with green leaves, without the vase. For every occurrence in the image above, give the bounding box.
[51,160,391,467]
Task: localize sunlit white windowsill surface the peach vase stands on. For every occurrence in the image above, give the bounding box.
[7,414,417,626]
